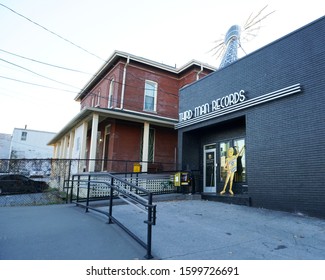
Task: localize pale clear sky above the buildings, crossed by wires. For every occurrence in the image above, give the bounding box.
[0,0,325,134]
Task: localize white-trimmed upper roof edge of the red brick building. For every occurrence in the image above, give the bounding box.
[75,51,217,101]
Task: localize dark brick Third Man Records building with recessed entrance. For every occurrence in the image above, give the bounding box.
[176,17,325,217]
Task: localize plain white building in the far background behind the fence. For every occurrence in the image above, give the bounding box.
[10,128,56,159]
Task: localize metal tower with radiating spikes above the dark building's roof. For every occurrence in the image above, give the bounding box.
[210,5,275,69]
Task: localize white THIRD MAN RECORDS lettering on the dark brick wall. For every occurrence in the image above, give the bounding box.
[179,90,246,122]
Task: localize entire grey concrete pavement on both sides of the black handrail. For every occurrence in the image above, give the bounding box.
[0,195,325,260]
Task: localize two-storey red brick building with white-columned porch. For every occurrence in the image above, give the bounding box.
[49,51,215,171]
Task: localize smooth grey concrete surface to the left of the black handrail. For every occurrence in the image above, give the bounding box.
[0,204,145,260]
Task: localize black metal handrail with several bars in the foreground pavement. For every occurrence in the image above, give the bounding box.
[70,173,156,259]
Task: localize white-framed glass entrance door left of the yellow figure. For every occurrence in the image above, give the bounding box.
[203,145,217,193]
